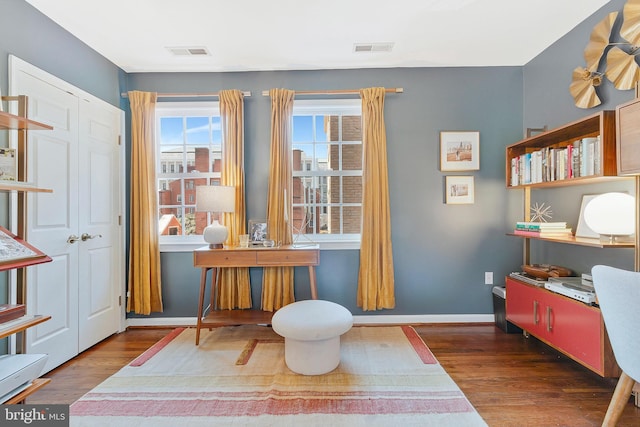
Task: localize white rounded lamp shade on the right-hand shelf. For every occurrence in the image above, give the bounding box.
[584,193,636,236]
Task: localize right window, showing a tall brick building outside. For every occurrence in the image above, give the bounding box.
[292,99,362,242]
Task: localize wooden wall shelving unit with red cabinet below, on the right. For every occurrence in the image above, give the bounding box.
[506,111,637,377]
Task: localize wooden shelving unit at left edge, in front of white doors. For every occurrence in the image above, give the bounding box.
[0,95,53,404]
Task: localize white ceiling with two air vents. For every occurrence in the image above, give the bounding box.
[26,0,608,72]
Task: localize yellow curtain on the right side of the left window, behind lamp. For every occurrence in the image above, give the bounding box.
[217,89,251,310]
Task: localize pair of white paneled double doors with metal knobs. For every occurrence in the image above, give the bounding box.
[10,58,124,371]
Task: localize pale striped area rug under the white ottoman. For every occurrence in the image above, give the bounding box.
[70,325,486,427]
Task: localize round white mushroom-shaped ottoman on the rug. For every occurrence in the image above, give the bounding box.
[271,300,353,375]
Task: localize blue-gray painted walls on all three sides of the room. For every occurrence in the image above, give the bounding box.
[0,0,632,317]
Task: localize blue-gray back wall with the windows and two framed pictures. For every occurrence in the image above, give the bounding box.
[128,67,523,316]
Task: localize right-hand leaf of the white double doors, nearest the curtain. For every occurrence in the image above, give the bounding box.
[78,99,124,351]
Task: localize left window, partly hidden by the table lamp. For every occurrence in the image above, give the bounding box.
[156,102,222,243]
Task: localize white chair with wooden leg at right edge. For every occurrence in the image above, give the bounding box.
[591,265,640,426]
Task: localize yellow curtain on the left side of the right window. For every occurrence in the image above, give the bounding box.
[262,89,295,311]
